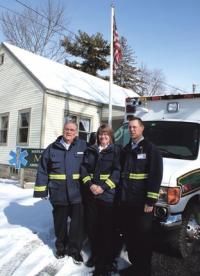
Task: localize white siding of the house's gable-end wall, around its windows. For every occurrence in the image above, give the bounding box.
[0,49,43,164]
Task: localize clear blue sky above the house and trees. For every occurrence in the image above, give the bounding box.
[0,0,200,92]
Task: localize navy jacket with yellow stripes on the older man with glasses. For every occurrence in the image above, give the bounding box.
[34,136,87,205]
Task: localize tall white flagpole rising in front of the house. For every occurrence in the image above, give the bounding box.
[108,4,114,127]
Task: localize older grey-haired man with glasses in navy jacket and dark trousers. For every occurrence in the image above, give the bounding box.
[34,121,87,264]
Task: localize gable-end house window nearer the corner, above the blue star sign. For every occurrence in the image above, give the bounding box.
[18,110,31,144]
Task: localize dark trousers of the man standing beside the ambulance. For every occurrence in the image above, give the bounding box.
[121,203,153,276]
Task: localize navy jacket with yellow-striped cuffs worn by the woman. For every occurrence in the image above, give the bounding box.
[81,144,120,203]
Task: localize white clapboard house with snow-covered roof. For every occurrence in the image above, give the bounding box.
[0,43,136,177]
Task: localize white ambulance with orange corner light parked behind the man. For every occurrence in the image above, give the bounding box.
[115,94,200,257]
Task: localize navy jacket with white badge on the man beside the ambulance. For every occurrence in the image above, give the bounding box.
[121,139,163,206]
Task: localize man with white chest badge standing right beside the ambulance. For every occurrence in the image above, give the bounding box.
[121,117,163,276]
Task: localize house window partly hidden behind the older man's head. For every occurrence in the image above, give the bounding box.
[65,113,91,141]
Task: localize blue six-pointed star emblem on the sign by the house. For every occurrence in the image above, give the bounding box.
[9,147,28,169]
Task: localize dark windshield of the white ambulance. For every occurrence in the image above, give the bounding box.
[144,121,199,160]
